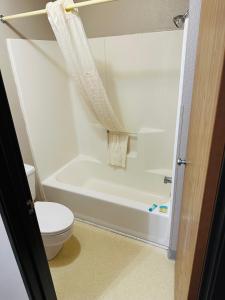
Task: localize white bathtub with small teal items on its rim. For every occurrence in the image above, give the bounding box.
[43,157,170,247]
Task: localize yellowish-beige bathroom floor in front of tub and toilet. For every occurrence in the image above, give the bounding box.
[50,222,174,300]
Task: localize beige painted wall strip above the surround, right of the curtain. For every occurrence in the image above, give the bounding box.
[80,0,189,37]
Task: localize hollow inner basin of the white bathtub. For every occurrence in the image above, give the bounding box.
[53,155,169,205]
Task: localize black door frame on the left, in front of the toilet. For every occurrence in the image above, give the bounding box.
[0,73,56,300]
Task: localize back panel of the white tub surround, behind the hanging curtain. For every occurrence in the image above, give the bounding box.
[71,31,183,175]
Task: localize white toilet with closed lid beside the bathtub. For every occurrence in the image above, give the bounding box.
[24,164,74,260]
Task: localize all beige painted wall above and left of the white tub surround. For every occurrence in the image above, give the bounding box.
[0,0,188,163]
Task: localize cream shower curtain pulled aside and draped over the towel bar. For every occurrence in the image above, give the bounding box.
[46,0,129,168]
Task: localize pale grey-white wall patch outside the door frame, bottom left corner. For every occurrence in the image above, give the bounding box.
[0,215,28,300]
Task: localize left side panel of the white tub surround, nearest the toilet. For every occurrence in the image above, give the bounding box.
[8,40,76,180]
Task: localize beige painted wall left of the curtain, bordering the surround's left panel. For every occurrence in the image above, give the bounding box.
[0,0,54,197]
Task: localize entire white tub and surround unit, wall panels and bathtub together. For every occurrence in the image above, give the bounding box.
[8,31,182,247]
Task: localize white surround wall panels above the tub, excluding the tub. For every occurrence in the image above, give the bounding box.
[8,30,183,197]
